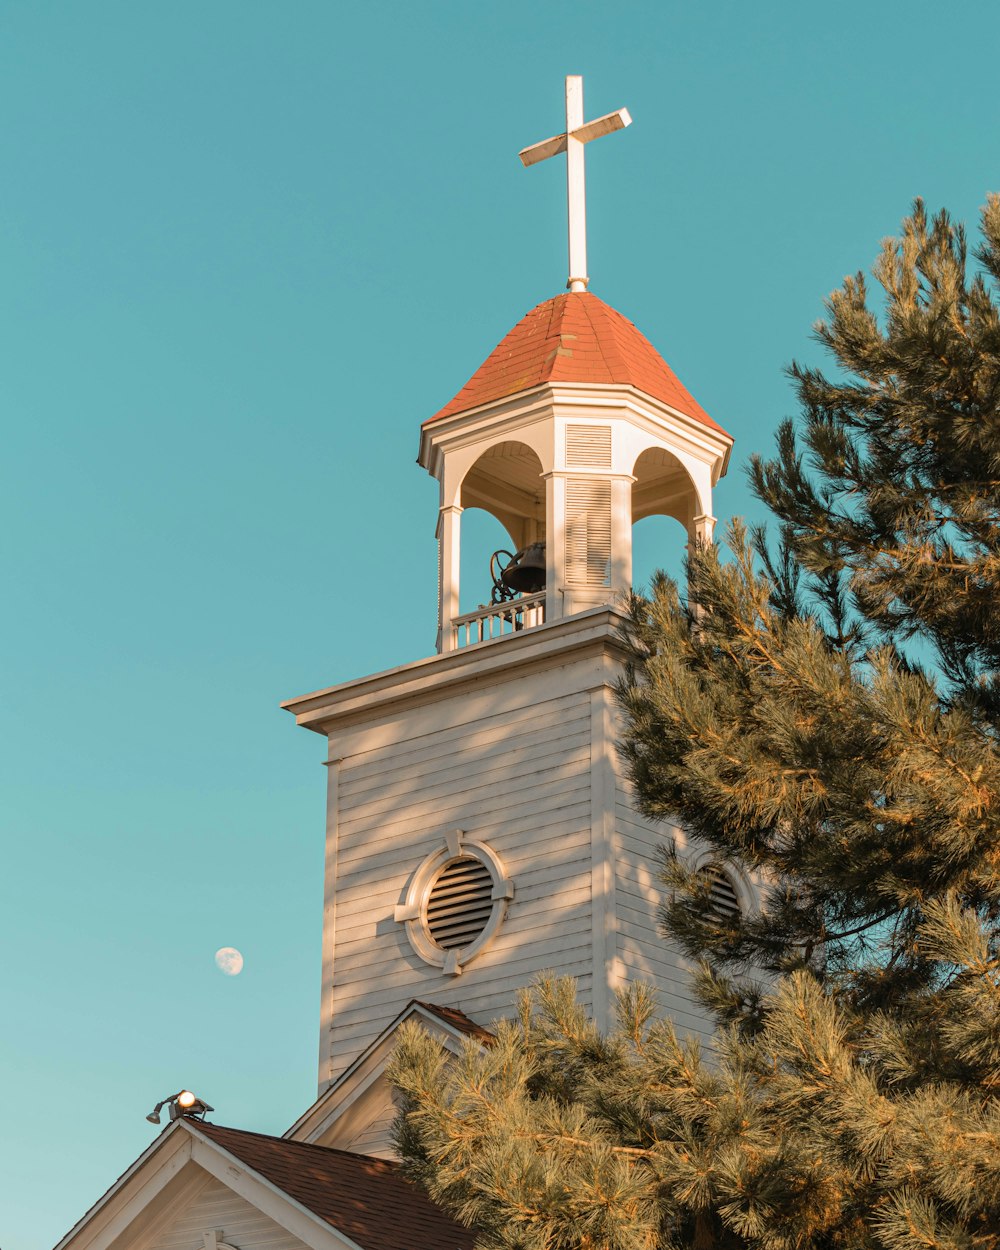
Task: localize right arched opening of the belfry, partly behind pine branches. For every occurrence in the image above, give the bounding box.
[633,448,699,593]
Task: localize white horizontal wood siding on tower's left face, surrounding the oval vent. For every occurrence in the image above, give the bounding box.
[323,664,600,1085]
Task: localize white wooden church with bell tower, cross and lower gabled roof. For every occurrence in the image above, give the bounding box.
[58,78,754,1250]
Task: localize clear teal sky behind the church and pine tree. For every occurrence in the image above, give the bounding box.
[0,0,1000,1250]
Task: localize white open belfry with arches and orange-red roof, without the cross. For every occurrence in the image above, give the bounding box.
[419,291,733,653]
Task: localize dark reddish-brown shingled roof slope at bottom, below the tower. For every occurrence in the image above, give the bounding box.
[194,1124,474,1250]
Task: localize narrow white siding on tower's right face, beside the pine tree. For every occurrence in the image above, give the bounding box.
[615,778,713,1041]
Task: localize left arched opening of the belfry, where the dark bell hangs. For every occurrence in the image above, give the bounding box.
[459,441,545,613]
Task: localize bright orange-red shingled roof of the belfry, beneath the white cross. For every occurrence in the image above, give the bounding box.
[424,291,725,434]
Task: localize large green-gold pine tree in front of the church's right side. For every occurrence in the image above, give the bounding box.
[394,198,1000,1250]
